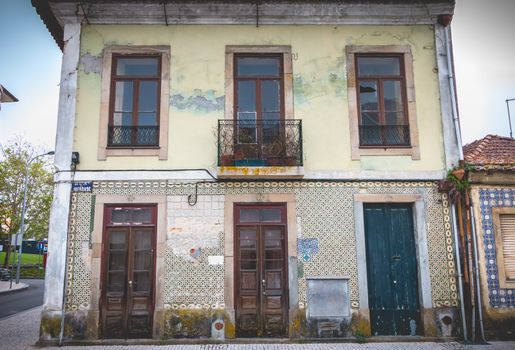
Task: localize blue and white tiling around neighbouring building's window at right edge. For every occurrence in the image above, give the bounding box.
[479,188,515,308]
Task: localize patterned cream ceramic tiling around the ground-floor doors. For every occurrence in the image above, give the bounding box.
[67,181,457,309]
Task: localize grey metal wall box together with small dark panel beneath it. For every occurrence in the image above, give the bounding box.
[306,277,350,337]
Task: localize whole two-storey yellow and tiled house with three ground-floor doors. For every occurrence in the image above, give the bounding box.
[33,0,459,341]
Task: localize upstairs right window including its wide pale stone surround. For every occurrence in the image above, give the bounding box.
[346,45,420,160]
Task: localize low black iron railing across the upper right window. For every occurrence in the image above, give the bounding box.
[359,125,410,147]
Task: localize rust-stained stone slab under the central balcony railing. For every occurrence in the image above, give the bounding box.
[217,166,304,179]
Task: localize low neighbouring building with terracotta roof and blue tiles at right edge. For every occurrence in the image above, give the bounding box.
[464,135,515,339]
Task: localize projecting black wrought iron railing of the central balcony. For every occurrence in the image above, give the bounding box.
[218,119,302,166]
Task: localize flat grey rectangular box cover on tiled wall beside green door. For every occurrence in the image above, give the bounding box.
[306,277,350,319]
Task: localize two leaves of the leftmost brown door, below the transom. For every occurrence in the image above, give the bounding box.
[102,223,155,338]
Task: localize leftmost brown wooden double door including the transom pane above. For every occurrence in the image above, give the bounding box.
[101,206,156,338]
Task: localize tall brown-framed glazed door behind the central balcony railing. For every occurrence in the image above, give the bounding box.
[234,54,284,165]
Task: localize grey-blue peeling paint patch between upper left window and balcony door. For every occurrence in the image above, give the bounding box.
[170,89,225,112]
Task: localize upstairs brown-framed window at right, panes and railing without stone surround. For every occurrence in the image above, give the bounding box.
[356,55,410,147]
